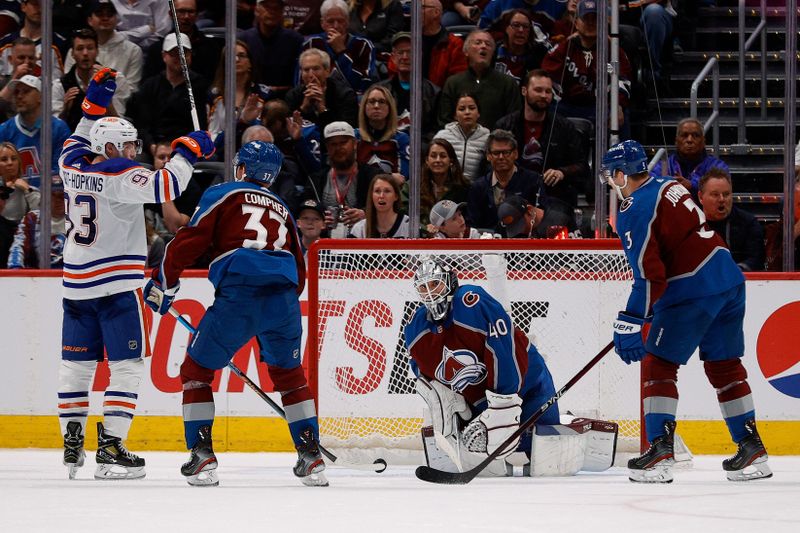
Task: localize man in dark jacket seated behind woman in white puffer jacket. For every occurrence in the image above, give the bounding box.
[438,30,522,129]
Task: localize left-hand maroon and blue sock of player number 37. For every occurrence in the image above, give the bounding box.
[181,354,214,450]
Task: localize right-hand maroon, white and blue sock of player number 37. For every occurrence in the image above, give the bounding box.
[267,365,319,446]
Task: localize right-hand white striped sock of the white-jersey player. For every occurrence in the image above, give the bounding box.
[103,358,144,441]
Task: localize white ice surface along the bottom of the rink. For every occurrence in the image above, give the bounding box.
[0,450,800,533]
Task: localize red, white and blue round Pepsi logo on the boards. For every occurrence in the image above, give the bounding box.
[756,302,800,398]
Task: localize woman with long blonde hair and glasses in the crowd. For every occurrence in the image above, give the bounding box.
[356,85,409,183]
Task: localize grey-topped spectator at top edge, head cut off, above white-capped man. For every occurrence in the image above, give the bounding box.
[110,0,173,50]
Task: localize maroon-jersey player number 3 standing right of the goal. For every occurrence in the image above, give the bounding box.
[600,141,772,483]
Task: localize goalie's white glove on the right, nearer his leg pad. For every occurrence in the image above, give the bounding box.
[461,390,522,457]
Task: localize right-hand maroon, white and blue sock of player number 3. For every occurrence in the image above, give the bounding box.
[703,358,756,442]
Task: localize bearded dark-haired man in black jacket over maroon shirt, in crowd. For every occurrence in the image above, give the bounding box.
[497,69,594,209]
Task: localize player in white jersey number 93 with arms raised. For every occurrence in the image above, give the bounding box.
[58,68,214,479]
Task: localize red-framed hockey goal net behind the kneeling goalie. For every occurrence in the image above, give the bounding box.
[308,239,640,462]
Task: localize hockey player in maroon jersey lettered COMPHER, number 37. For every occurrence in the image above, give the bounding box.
[145,141,328,486]
